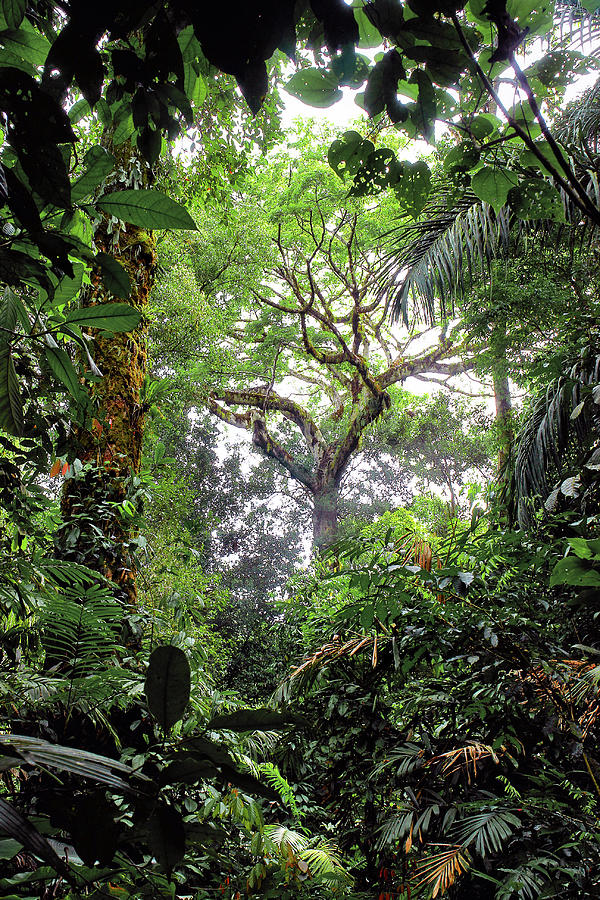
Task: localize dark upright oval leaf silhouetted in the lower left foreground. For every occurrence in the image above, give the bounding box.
[144,645,190,731]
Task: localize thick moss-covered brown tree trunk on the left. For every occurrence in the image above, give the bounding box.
[58,142,156,605]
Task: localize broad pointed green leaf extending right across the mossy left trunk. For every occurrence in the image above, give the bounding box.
[96,190,196,231]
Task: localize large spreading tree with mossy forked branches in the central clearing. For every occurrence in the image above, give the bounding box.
[202,142,478,545]
